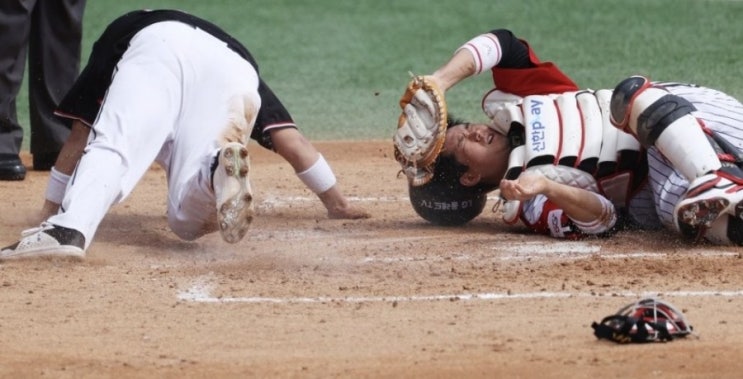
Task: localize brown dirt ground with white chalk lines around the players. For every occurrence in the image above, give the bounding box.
[0,141,743,378]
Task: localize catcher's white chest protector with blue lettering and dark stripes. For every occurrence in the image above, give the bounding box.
[482,90,648,223]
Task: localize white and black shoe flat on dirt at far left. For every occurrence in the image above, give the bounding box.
[0,222,85,260]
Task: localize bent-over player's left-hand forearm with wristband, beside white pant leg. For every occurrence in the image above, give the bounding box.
[39,120,90,220]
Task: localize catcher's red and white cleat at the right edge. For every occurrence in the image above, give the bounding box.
[674,174,743,230]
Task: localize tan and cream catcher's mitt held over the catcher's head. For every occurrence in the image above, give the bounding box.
[393,76,447,186]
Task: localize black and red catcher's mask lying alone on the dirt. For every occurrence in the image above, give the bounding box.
[591,299,692,343]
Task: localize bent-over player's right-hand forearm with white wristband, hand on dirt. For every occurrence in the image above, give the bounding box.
[270,128,370,219]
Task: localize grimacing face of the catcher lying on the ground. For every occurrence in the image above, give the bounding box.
[444,124,508,185]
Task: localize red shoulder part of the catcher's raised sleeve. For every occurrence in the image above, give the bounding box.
[491,40,578,97]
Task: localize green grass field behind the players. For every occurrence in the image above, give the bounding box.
[13,0,743,146]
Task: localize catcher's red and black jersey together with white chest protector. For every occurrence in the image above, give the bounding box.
[482,30,647,238]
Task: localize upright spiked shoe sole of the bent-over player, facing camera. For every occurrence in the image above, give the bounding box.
[212,142,254,243]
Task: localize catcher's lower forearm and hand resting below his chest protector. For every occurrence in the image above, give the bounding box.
[500,173,617,234]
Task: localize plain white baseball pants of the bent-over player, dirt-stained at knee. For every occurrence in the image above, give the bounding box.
[48,21,261,248]
